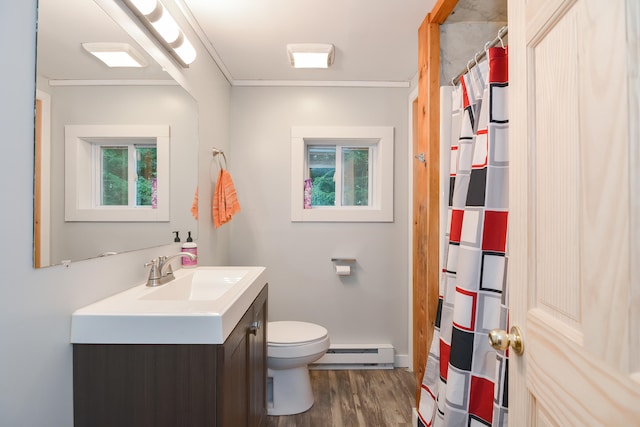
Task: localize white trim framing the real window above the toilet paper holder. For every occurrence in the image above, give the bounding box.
[291,126,393,222]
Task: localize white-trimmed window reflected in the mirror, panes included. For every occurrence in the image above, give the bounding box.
[65,125,169,222]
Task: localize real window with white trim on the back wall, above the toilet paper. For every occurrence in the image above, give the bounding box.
[291,127,393,222]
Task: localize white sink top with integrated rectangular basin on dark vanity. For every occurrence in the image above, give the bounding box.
[71,266,267,344]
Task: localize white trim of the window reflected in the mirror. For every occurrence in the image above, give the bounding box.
[65,125,170,222]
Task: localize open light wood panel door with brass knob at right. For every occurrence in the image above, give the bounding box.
[508,0,640,426]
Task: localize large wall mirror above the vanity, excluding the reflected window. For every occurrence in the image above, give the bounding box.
[34,0,198,268]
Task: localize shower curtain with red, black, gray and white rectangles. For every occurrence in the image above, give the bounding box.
[418,47,509,427]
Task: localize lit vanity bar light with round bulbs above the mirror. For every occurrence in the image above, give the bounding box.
[125,0,196,68]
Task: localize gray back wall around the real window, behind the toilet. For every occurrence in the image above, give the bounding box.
[228,87,409,362]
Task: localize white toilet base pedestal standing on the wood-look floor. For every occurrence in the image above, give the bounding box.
[267,365,314,415]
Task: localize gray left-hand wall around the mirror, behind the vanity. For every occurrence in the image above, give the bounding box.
[0,0,230,427]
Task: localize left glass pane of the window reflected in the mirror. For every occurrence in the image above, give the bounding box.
[100,147,129,206]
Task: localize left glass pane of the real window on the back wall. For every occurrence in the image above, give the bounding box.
[307,145,336,206]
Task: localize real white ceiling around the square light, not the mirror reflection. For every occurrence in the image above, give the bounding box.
[178,0,436,84]
